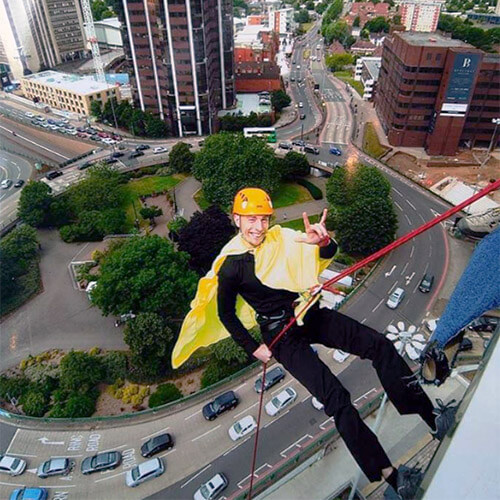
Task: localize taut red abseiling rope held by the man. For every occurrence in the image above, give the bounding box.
[248,179,500,500]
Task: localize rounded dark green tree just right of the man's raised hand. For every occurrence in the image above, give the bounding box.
[336,198,397,256]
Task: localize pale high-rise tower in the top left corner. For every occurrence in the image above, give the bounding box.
[0,0,88,79]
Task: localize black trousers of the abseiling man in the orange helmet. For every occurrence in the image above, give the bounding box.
[261,306,433,481]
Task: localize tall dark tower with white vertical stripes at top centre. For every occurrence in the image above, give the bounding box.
[122,0,235,137]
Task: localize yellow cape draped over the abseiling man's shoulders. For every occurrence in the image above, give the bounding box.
[172,226,331,368]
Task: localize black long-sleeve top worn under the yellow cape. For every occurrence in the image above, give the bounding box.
[217,240,337,356]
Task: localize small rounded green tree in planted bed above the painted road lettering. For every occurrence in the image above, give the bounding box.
[60,351,103,392]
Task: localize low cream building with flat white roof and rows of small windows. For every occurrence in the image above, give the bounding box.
[21,71,120,116]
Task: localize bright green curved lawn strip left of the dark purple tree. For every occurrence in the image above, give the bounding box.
[123,174,186,230]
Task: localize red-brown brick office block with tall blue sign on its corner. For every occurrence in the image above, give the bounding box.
[375,32,500,155]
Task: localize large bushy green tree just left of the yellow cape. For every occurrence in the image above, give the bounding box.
[92,235,198,318]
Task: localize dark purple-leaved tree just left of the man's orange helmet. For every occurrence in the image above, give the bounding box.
[179,205,235,274]
